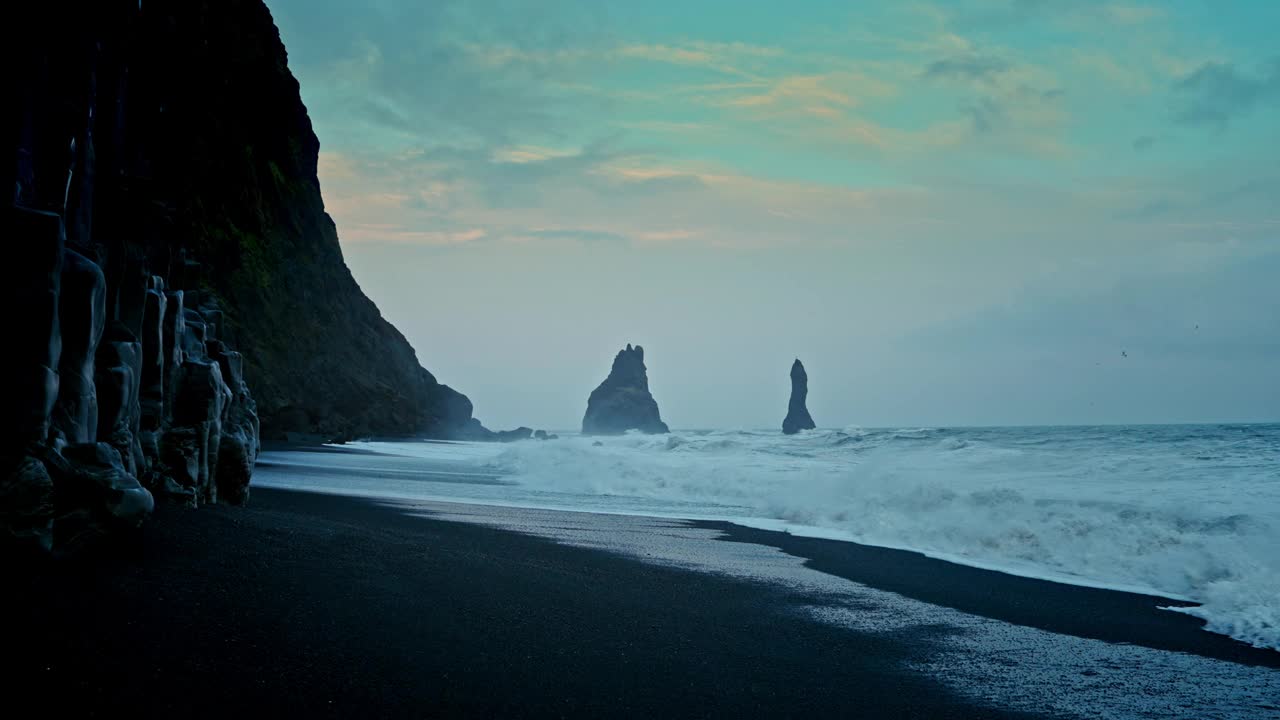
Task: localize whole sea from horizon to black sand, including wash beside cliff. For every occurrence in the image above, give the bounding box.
[255,424,1280,650]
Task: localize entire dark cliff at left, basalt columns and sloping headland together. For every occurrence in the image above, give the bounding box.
[0,0,490,547]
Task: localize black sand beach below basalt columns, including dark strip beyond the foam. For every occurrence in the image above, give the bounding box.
[5,489,1280,717]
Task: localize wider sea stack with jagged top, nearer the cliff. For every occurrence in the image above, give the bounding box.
[582,345,669,436]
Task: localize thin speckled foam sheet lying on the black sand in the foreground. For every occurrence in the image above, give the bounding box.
[420,503,1280,720]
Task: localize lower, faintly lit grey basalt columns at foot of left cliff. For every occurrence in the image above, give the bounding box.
[0,199,259,550]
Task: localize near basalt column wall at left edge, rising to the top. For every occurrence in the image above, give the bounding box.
[0,1,272,550]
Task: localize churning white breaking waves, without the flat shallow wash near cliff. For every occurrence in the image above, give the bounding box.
[486,428,1280,650]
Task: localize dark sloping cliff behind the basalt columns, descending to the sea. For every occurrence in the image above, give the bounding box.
[132,0,477,438]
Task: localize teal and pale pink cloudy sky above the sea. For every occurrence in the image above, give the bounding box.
[268,0,1280,429]
